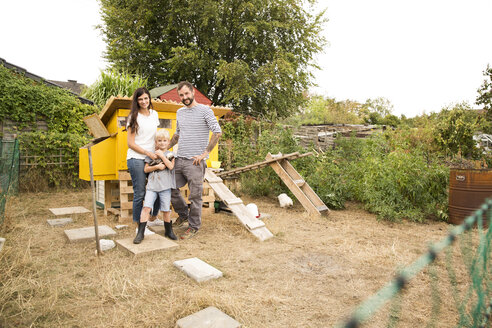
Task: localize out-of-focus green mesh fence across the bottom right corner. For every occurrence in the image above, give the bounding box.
[336,199,492,328]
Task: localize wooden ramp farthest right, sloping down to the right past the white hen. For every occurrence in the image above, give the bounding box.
[266,153,330,215]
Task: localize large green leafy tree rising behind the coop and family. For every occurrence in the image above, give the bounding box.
[99,0,326,117]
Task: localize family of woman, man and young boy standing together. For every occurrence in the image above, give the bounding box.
[126,81,222,244]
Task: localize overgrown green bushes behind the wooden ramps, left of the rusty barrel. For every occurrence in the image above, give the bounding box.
[219,117,449,222]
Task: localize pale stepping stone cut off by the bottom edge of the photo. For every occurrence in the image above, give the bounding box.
[176,306,241,328]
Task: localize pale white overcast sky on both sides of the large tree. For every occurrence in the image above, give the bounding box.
[0,0,492,117]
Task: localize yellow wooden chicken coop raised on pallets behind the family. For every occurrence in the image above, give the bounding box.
[79,97,230,219]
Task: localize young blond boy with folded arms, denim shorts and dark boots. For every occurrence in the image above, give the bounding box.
[140,129,178,240]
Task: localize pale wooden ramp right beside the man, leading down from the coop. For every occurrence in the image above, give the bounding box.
[205,169,273,241]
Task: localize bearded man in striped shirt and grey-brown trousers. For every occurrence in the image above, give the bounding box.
[169,81,222,239]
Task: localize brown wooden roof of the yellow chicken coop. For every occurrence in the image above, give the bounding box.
[99,97,231,124]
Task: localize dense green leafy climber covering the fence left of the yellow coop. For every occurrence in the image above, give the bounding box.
[0,66,96,191]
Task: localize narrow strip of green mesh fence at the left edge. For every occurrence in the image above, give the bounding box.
[0,139,19,224]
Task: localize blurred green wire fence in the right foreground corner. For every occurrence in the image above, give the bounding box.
[335,199,492,328]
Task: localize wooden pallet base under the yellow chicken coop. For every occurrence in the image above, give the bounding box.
[104,171,215,222]
